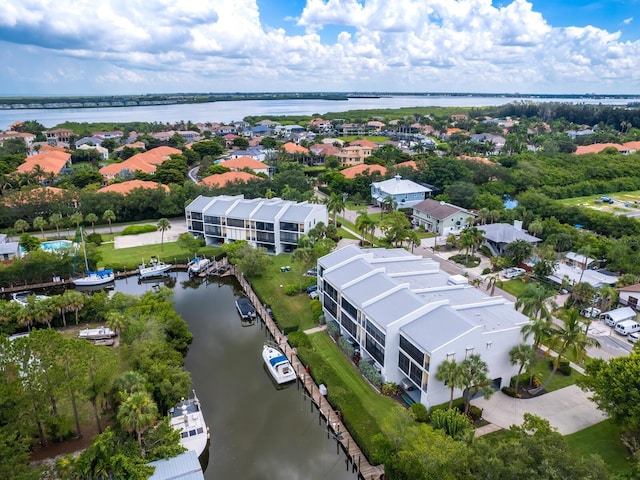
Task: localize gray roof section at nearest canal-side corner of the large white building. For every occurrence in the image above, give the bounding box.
[400,305,474,353]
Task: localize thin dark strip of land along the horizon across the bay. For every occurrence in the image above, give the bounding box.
[0,92,640,111]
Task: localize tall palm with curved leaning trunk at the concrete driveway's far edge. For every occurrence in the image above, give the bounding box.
[531,308,600,395]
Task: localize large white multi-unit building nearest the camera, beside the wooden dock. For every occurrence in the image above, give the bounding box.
[318,245,529,408]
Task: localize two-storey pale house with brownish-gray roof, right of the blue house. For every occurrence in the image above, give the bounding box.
[413,198,476,236]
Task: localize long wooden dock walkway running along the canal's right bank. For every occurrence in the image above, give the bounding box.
[229,265,384,480]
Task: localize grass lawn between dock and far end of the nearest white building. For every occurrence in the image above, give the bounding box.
[251,253,318,330]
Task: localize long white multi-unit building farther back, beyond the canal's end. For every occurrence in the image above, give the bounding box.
[185,195,328,254]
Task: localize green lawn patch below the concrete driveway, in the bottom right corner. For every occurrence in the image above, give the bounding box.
[565,420,630,473]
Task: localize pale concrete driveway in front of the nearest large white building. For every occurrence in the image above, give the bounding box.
[471,385,607,435]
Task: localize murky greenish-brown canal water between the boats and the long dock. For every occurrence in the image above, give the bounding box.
[116,273,356,480]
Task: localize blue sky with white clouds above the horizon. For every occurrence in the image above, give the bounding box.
[0,0,640,95]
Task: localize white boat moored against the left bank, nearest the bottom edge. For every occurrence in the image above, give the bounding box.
[169,391,209,457]
